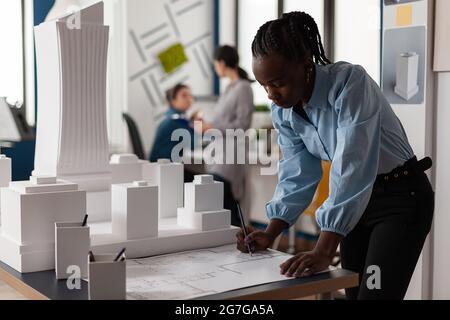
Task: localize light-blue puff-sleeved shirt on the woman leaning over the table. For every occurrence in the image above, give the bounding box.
[266,62,414,236]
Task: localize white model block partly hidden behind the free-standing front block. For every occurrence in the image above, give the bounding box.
[142,160,184,219]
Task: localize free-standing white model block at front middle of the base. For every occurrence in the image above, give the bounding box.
[111,182,158,240]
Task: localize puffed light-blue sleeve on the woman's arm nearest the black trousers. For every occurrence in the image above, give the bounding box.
[317,66,382,236]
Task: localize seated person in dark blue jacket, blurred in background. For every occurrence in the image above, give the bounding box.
[150,84,195,182]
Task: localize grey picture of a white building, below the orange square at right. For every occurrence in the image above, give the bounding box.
[382,26,426,105]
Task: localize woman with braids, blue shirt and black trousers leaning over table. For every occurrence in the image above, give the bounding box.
[237,12,434,299]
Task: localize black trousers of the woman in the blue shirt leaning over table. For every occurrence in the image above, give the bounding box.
[341,162,434,300]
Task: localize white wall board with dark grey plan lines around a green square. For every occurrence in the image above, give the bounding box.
[124,0,214,152]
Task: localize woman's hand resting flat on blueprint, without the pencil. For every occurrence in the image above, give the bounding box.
[280,250,332,278]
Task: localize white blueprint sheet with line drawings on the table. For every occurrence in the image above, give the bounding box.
[127,245,291,300]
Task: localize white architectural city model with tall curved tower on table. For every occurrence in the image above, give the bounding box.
[0,3,236,273]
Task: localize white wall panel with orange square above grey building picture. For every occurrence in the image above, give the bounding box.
[382,0,427,105]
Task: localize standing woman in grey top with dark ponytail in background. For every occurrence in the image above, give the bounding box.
[196,46,255,226]
